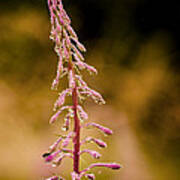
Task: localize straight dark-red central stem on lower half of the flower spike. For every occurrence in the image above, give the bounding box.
[72,86,80,174]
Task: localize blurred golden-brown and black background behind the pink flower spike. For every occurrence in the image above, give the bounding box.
[0,0,180,180]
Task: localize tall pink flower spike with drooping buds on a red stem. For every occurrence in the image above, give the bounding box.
[43,0,121,180]
